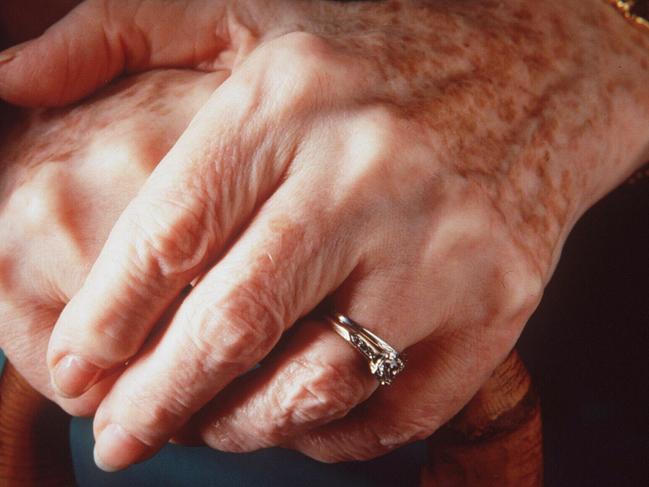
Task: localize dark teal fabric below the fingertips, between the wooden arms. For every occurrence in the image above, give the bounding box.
[71,419,425,487]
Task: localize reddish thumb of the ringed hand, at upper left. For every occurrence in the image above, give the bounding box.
[0,0,229,106]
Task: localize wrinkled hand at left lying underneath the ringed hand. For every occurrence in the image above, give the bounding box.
[0,70,224,415]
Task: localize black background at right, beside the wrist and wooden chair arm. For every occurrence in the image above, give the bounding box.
[519,167,649,487]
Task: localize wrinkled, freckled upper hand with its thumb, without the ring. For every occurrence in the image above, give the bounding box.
[0,0,649,469]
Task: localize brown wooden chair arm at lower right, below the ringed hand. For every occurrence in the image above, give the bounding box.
[421,351,543,487]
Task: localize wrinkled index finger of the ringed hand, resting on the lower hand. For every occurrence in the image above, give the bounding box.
[48,61,282,397]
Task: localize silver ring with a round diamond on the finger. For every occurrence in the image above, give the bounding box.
[327,313,405,386]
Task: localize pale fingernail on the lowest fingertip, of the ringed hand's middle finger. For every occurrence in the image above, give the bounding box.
[93,424,149,472]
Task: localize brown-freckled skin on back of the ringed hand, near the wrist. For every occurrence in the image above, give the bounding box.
[278,0,649,274]
